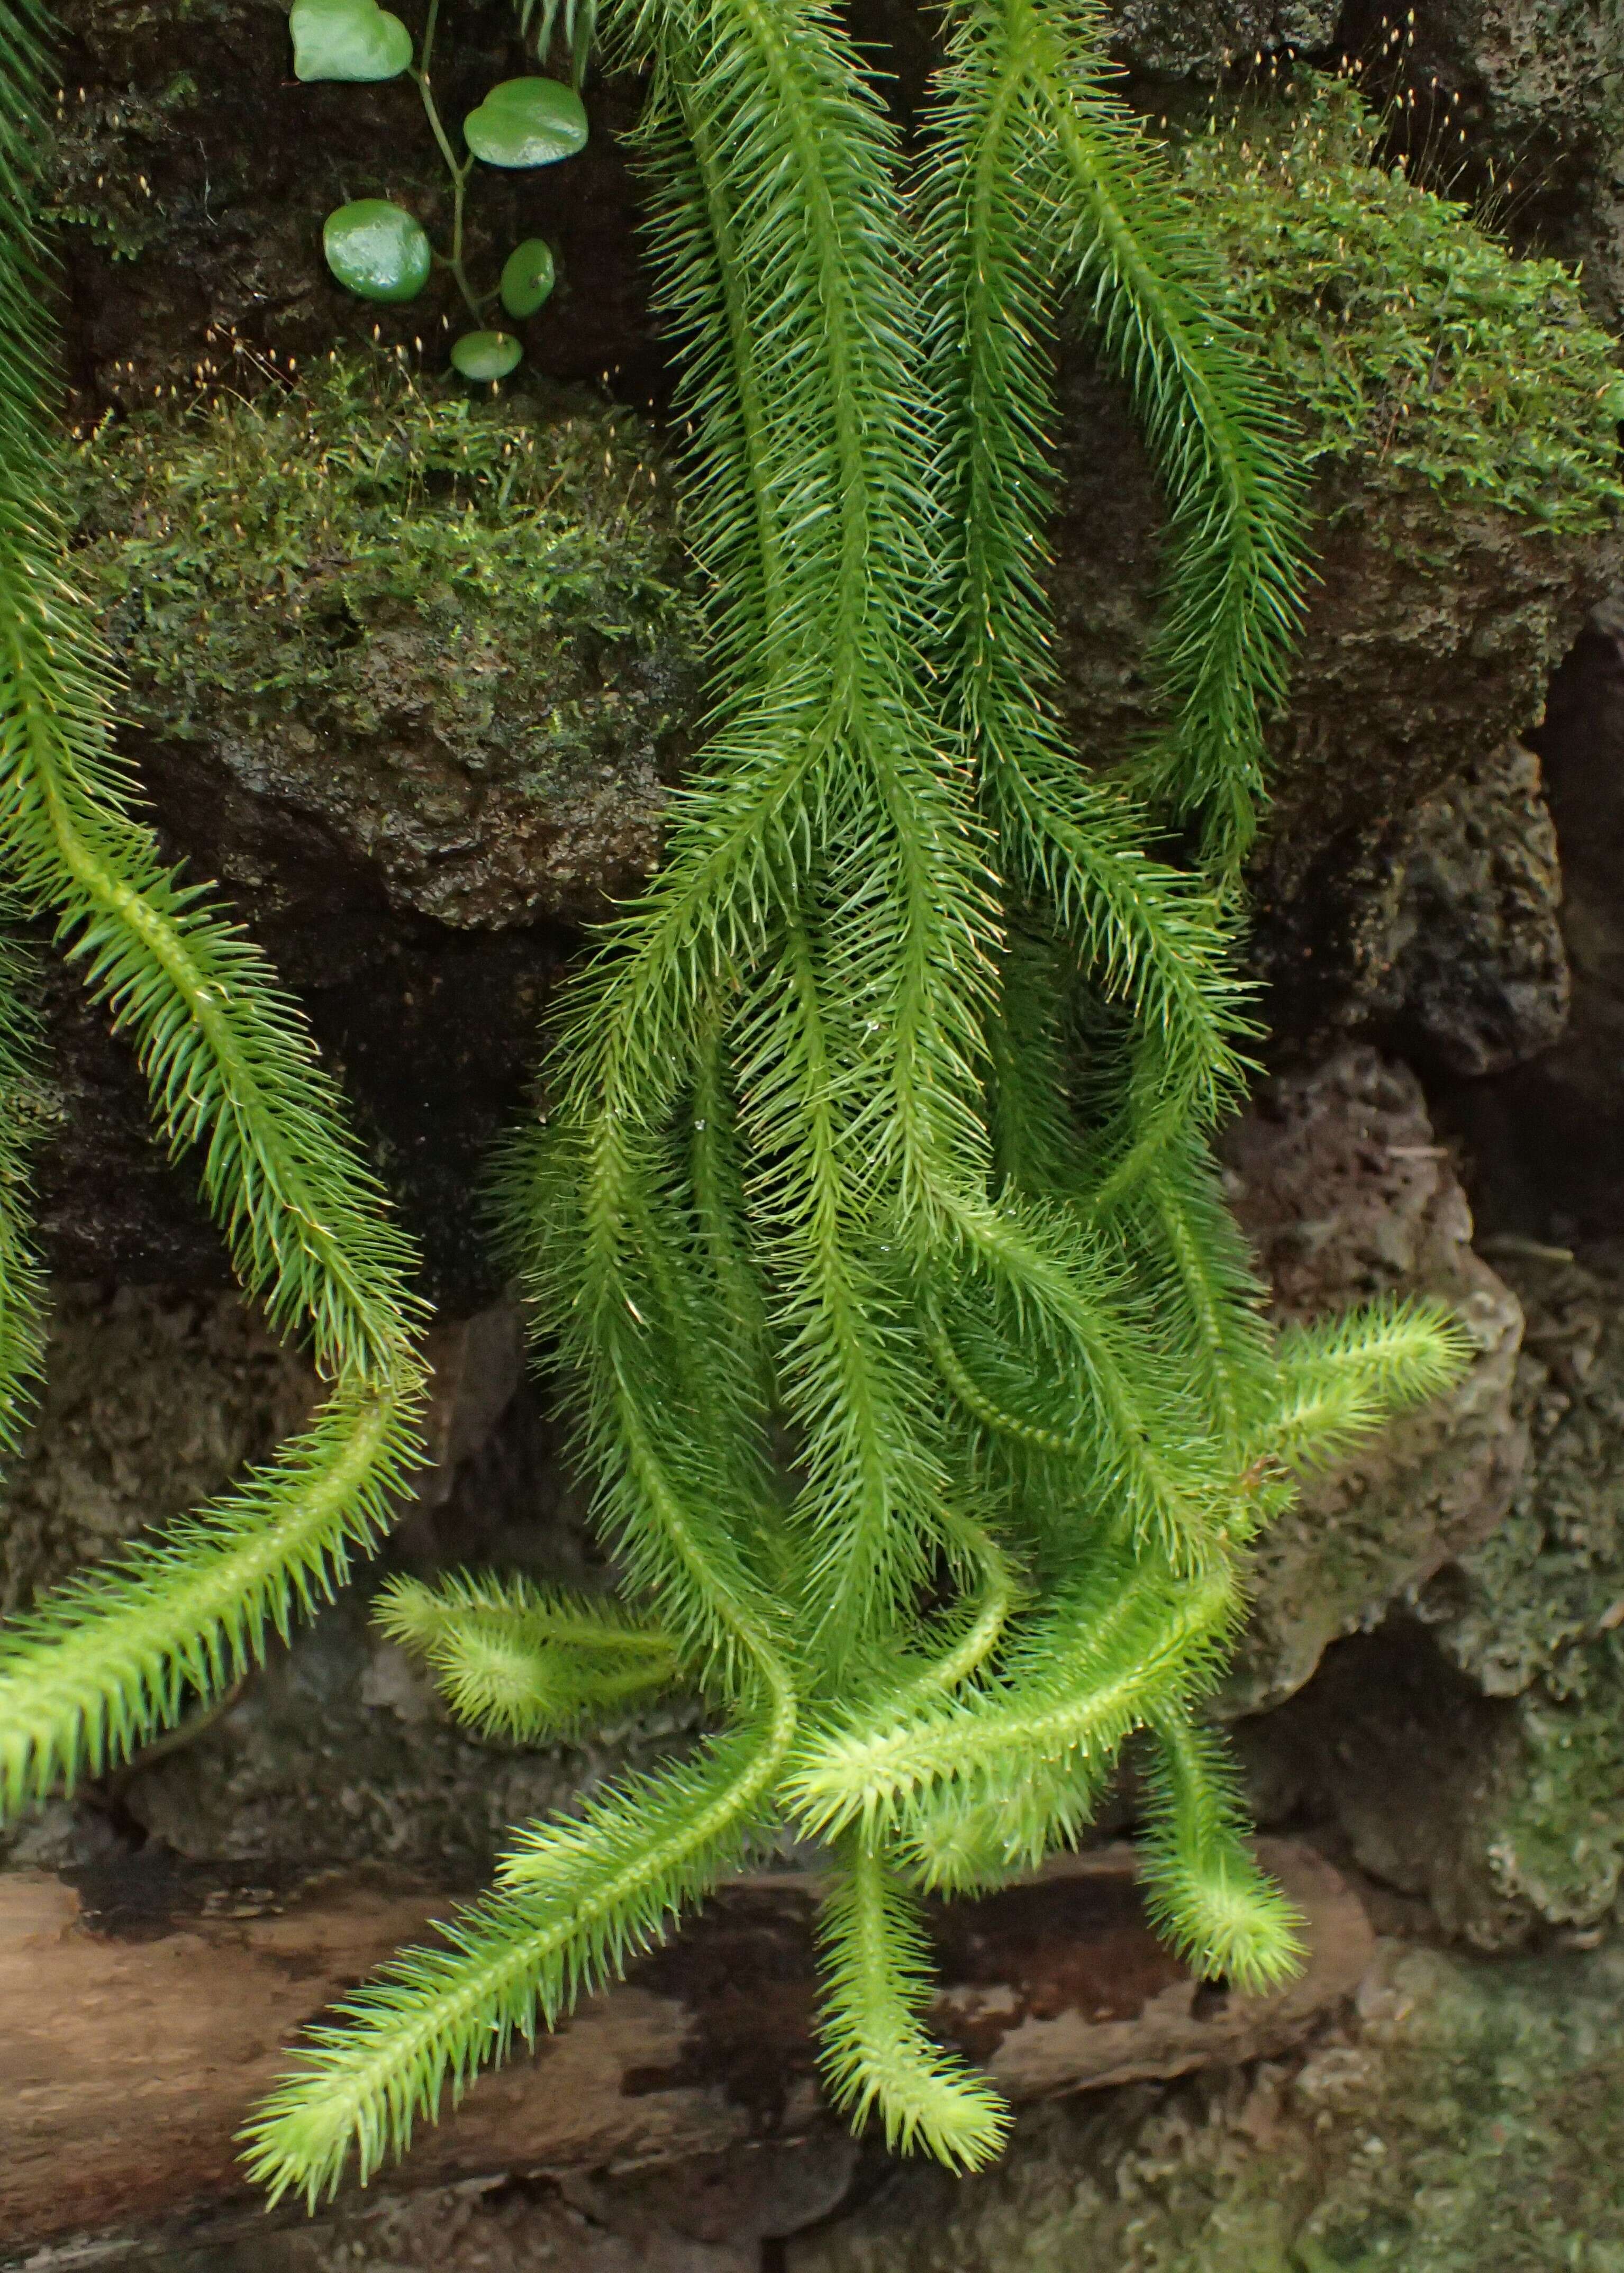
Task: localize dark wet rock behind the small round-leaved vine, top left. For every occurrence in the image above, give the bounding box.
[57,0,657,414]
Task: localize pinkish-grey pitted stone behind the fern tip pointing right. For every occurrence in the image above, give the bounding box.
[1223,1048,1524,1712]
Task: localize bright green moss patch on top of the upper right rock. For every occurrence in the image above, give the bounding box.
[1183,79,1624,534]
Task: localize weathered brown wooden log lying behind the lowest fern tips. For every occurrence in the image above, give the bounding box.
[0,1841,1372,2252]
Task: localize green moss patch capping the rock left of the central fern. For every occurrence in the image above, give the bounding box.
[73,357,685,723]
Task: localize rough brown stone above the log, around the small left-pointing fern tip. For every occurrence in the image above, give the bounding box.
[99,1354,701,1882]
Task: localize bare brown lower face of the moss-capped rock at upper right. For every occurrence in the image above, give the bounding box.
[1037,341,1610,1054]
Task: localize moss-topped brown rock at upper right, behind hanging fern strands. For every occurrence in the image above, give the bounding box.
[1053,82,1624,1039]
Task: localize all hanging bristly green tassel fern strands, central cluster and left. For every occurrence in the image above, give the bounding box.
[0,0,1463,2205]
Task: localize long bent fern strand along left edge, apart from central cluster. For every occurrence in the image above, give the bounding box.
[0,0,421,1812]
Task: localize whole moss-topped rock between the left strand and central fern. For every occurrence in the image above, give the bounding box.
[75,357,698,930]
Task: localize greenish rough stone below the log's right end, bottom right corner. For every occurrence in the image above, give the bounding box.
[787,1943,1624,2273]
